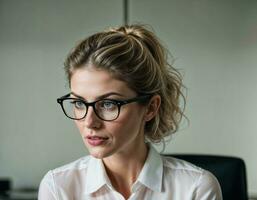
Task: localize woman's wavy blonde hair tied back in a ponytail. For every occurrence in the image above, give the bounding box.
[64,24,185,143]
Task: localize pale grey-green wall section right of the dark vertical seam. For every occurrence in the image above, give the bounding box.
[130,0,257,194]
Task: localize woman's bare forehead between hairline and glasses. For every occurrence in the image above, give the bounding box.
[70,67,136,100]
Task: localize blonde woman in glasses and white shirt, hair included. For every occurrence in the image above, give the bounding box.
[39,25,222,200]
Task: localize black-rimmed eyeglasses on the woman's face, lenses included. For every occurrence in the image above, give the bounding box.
[57,94,151,121]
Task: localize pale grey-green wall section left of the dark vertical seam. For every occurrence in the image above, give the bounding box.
[0,0,123,188]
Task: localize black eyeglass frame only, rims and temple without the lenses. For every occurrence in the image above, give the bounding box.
[57,93,152,121]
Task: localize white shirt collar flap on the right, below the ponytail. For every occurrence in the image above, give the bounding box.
[137,145,163,192]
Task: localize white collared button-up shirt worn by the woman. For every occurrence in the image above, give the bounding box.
[38,145,222,200]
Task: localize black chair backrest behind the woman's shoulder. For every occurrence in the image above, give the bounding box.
[164,154,248,200]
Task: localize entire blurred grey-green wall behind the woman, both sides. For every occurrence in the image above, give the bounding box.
[0,0,257,197]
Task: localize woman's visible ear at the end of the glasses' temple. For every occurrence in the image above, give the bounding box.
[144,95,161,122]
